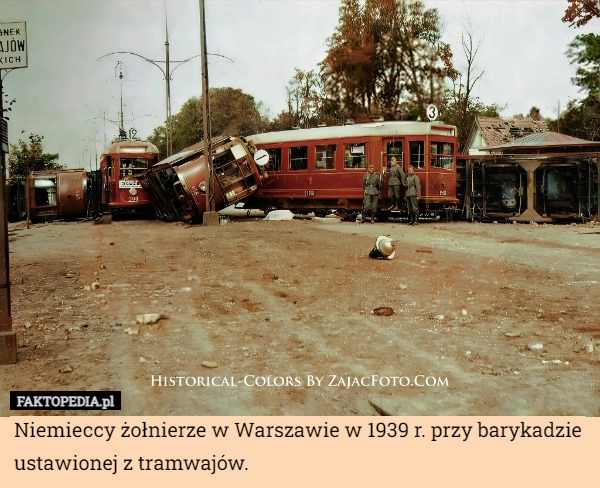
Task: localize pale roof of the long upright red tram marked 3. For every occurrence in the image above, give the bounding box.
[246,121,456,144]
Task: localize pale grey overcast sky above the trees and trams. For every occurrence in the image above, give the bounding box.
[0,0,600,169]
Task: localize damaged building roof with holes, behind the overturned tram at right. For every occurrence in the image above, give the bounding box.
[475,116,548,150]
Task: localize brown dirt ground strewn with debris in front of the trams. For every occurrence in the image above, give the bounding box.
[0,214,600,416]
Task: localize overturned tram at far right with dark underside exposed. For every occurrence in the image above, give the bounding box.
[457,132,600,223]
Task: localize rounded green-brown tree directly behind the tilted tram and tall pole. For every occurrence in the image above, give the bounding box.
[148,87,268,154]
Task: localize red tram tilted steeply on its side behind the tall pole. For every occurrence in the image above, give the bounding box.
[140,136,264,223]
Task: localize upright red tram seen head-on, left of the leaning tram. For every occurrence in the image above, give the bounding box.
[99,139,159,216]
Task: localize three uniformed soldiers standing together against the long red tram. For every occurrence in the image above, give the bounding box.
[363,157,421,225]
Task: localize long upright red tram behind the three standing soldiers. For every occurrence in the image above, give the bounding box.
[247,121,458,218]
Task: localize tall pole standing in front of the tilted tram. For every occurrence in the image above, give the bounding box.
[198,0,219,225]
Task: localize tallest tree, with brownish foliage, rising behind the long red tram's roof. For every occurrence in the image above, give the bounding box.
[321,0,453,119]
